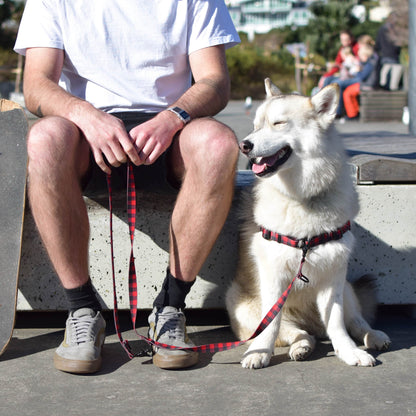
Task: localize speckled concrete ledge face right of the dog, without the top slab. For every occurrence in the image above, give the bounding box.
[349,184,416,305]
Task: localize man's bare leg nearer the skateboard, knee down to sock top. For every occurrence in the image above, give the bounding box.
[28,117,89,289]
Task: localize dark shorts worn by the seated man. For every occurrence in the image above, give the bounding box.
[82,112,179,194]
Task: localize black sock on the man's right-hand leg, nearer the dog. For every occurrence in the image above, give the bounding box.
[153,269,195,309]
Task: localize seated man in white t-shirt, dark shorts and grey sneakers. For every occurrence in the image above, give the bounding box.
[15,0,239,373]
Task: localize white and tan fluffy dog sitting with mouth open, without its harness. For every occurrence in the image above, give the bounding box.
[226,79,390,368]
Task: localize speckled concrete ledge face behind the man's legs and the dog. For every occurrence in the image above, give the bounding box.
[18,164,416,311]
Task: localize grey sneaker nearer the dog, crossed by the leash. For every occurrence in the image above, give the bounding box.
[149,306,198,369]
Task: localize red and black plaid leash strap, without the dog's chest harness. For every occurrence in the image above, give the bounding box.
[107,163,299,359]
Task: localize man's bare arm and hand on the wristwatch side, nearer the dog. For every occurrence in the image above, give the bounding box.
[130,45,230,164]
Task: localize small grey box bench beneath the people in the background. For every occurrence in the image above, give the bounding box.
[360,90,407,122]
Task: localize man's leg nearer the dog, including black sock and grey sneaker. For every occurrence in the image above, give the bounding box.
[149,118,238,369]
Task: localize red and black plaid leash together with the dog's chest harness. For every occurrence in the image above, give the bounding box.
[107,163,349,358]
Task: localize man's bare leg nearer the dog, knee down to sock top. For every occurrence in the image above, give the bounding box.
[170,118,238,282]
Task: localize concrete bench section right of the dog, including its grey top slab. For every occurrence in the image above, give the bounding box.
[349,157,416,305]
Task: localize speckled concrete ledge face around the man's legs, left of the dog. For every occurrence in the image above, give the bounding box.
[18,172,251,310]
